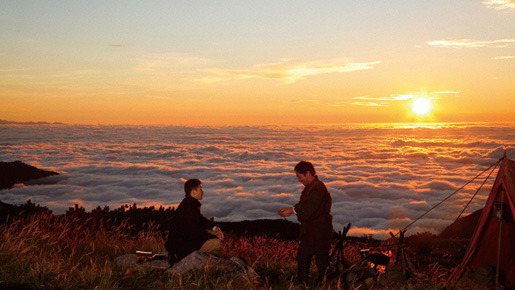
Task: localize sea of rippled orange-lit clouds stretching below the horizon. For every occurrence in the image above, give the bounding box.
[0,123,515,238]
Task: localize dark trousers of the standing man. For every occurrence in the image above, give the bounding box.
[297,241,330,284]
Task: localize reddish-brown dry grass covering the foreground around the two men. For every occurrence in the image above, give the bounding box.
[0,215,454,289]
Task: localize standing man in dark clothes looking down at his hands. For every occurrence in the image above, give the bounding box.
[278,161,333,284]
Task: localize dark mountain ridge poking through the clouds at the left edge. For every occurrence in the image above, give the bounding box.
[0,161,59,189]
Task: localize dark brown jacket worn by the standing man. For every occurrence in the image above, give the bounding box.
[295,176,333,252]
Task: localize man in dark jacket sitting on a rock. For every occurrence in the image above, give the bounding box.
[165,179,224,265]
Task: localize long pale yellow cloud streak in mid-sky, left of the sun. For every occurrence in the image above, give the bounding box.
[207,59,381,84]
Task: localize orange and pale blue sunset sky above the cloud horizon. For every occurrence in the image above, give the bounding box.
[0,0,515,125]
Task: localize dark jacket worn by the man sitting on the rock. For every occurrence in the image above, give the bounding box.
[165,196,216,264]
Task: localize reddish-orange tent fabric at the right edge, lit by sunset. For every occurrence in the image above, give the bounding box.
[451,156,515,288]
